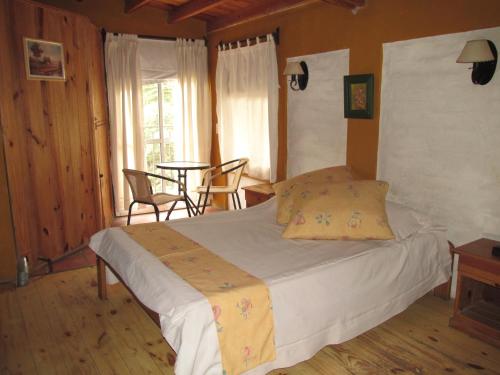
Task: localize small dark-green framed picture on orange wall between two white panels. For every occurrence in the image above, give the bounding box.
[344,74,373,118]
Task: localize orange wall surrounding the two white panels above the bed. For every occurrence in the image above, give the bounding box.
[208,0,500,179]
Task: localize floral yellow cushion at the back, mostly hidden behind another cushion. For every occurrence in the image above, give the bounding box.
[273,165,361,224]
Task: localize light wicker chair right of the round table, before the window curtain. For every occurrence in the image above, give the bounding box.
[195,158,248,214]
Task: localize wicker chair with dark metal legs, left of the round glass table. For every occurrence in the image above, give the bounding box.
[123,169,184,225]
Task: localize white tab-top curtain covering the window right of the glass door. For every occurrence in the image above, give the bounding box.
[216,34,279,182]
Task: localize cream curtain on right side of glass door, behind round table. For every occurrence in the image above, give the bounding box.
[175,39,212,188]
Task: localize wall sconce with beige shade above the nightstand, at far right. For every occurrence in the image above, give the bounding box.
[457,39,498,85]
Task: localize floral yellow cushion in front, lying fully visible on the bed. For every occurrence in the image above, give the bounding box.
[283,180,394,240]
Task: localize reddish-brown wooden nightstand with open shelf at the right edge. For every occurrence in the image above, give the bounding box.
[450,238,500,347]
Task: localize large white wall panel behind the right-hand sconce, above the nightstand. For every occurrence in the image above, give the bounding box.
[378,28,500,250]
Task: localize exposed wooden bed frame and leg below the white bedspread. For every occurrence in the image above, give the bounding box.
[96,241,455,327]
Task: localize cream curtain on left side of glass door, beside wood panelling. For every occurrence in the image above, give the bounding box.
[105,33,144,215]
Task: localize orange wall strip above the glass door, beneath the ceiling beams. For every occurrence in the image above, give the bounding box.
[38,0,206,38]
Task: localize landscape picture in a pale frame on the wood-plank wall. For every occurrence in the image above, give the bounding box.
[23,38,66,81]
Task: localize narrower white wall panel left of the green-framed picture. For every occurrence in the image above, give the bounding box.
[287,50,349,177]
